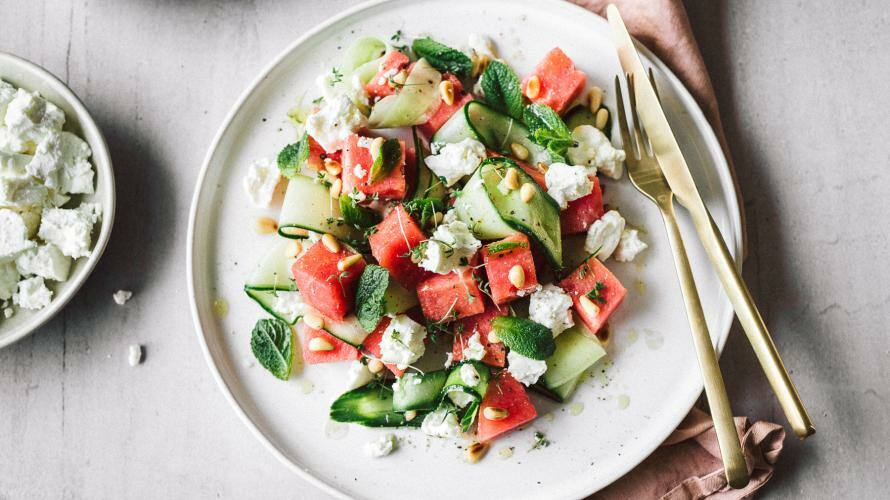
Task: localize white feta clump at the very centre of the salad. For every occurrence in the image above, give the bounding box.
[420,210,482,274]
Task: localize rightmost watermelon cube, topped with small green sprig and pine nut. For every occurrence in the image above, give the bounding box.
[559,257,627,333]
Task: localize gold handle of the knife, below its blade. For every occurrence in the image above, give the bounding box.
[689,207,816,439]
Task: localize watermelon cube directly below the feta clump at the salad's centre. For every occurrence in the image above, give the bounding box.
[417,268,485,322]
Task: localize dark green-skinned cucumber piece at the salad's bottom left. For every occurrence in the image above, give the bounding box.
[330,383,423,427]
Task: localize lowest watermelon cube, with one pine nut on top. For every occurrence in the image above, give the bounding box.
[476,370,538,443]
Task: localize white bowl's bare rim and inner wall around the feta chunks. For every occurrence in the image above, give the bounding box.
[0,52,115,349]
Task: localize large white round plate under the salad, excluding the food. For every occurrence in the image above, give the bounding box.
[188,0,741,498]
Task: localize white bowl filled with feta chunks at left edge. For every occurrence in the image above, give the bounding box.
[0,52,115,348]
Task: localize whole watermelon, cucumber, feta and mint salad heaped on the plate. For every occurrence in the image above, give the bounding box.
[244,32,647,461]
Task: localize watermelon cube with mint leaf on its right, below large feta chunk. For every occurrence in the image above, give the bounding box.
[342,134,408,200]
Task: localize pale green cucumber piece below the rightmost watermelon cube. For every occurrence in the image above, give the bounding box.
[542,323,606,389]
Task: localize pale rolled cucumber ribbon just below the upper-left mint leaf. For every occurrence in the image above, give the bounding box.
[278,175,361,241]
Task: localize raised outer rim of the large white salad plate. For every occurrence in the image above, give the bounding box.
[186,0,742,498]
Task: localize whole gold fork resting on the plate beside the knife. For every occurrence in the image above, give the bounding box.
[615,71,749,488]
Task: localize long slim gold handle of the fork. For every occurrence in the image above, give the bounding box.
[658,195,749,488]
